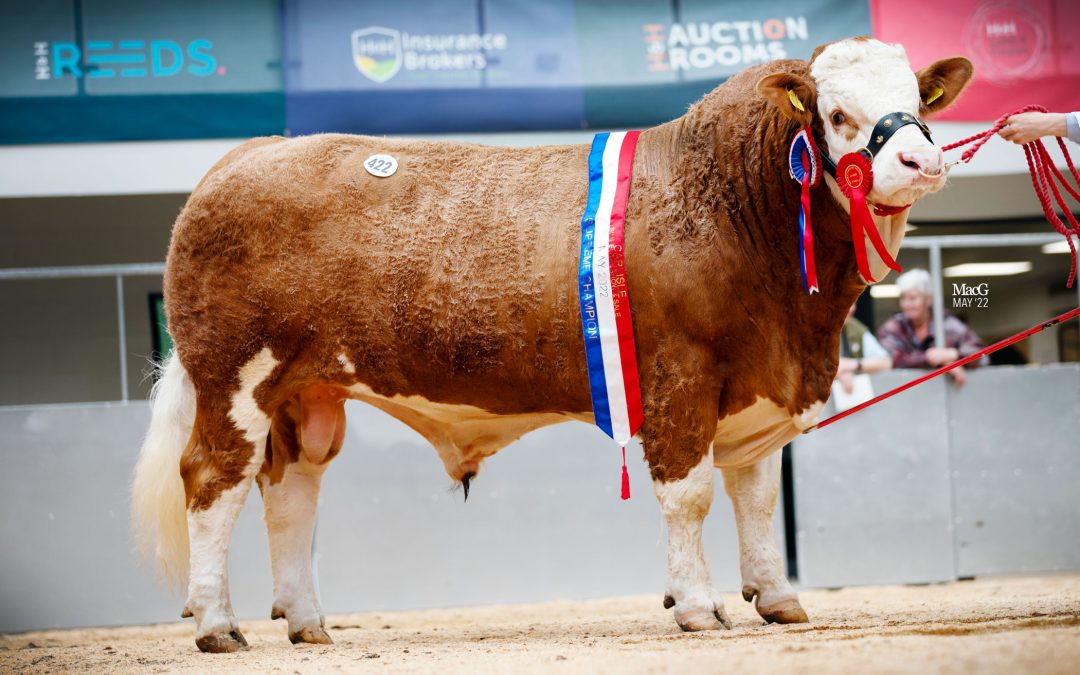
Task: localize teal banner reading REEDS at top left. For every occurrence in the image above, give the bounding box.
[0,0,285,144]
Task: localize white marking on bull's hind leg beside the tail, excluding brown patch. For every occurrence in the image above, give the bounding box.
[186,348,278,637]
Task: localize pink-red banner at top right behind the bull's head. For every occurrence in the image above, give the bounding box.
[870,0,1080,122]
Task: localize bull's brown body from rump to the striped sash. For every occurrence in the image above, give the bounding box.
[165,135,589,413]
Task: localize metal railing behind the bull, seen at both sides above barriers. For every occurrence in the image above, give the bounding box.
[0,232,1080,403]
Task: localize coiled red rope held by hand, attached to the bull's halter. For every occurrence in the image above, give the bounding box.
[942,105,1080,288]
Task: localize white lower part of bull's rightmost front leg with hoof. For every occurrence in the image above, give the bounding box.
[723,453,808,623]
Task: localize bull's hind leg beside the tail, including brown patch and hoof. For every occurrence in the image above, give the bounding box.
[180,349,276,652]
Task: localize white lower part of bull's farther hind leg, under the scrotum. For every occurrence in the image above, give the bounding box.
[259,457,326,637]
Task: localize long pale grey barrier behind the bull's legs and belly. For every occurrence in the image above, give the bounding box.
[0,402,783,635]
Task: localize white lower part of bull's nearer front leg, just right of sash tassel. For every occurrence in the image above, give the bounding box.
[652,446,730,631]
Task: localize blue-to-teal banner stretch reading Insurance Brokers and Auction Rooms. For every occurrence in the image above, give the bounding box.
[283,0,870,134]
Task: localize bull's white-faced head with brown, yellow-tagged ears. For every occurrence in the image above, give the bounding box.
[757,38,974,279]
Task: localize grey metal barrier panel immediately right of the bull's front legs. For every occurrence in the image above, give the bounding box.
[792,370,956,588]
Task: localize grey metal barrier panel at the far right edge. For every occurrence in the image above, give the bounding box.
[948,363,1080,577]
